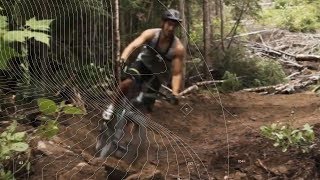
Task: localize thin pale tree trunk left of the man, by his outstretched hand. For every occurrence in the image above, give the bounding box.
[115,0,121,82]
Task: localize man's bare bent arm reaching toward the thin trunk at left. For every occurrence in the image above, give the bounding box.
[120,29,154,60]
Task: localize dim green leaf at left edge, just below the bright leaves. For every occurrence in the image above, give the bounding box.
[0,41,20,70]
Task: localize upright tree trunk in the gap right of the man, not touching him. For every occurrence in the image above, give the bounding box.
[203,0,210,78]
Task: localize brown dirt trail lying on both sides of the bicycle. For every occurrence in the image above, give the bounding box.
[10,92,320,179]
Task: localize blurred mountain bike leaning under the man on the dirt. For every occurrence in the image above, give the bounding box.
[96,82,177,163]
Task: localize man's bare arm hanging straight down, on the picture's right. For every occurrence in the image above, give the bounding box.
[171,44,185,96]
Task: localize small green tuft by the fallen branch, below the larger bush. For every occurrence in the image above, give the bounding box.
[221,71,241,92]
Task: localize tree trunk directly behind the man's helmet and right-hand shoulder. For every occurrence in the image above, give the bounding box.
[179,0,188,89]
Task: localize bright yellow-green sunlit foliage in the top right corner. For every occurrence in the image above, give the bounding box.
[261,0,320,32]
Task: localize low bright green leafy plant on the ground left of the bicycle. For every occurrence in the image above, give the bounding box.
[37,98,85,139]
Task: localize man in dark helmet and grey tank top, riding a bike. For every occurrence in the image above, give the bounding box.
[103,9,185,120]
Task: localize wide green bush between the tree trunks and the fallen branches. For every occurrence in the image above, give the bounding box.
[213,47,286,89]
